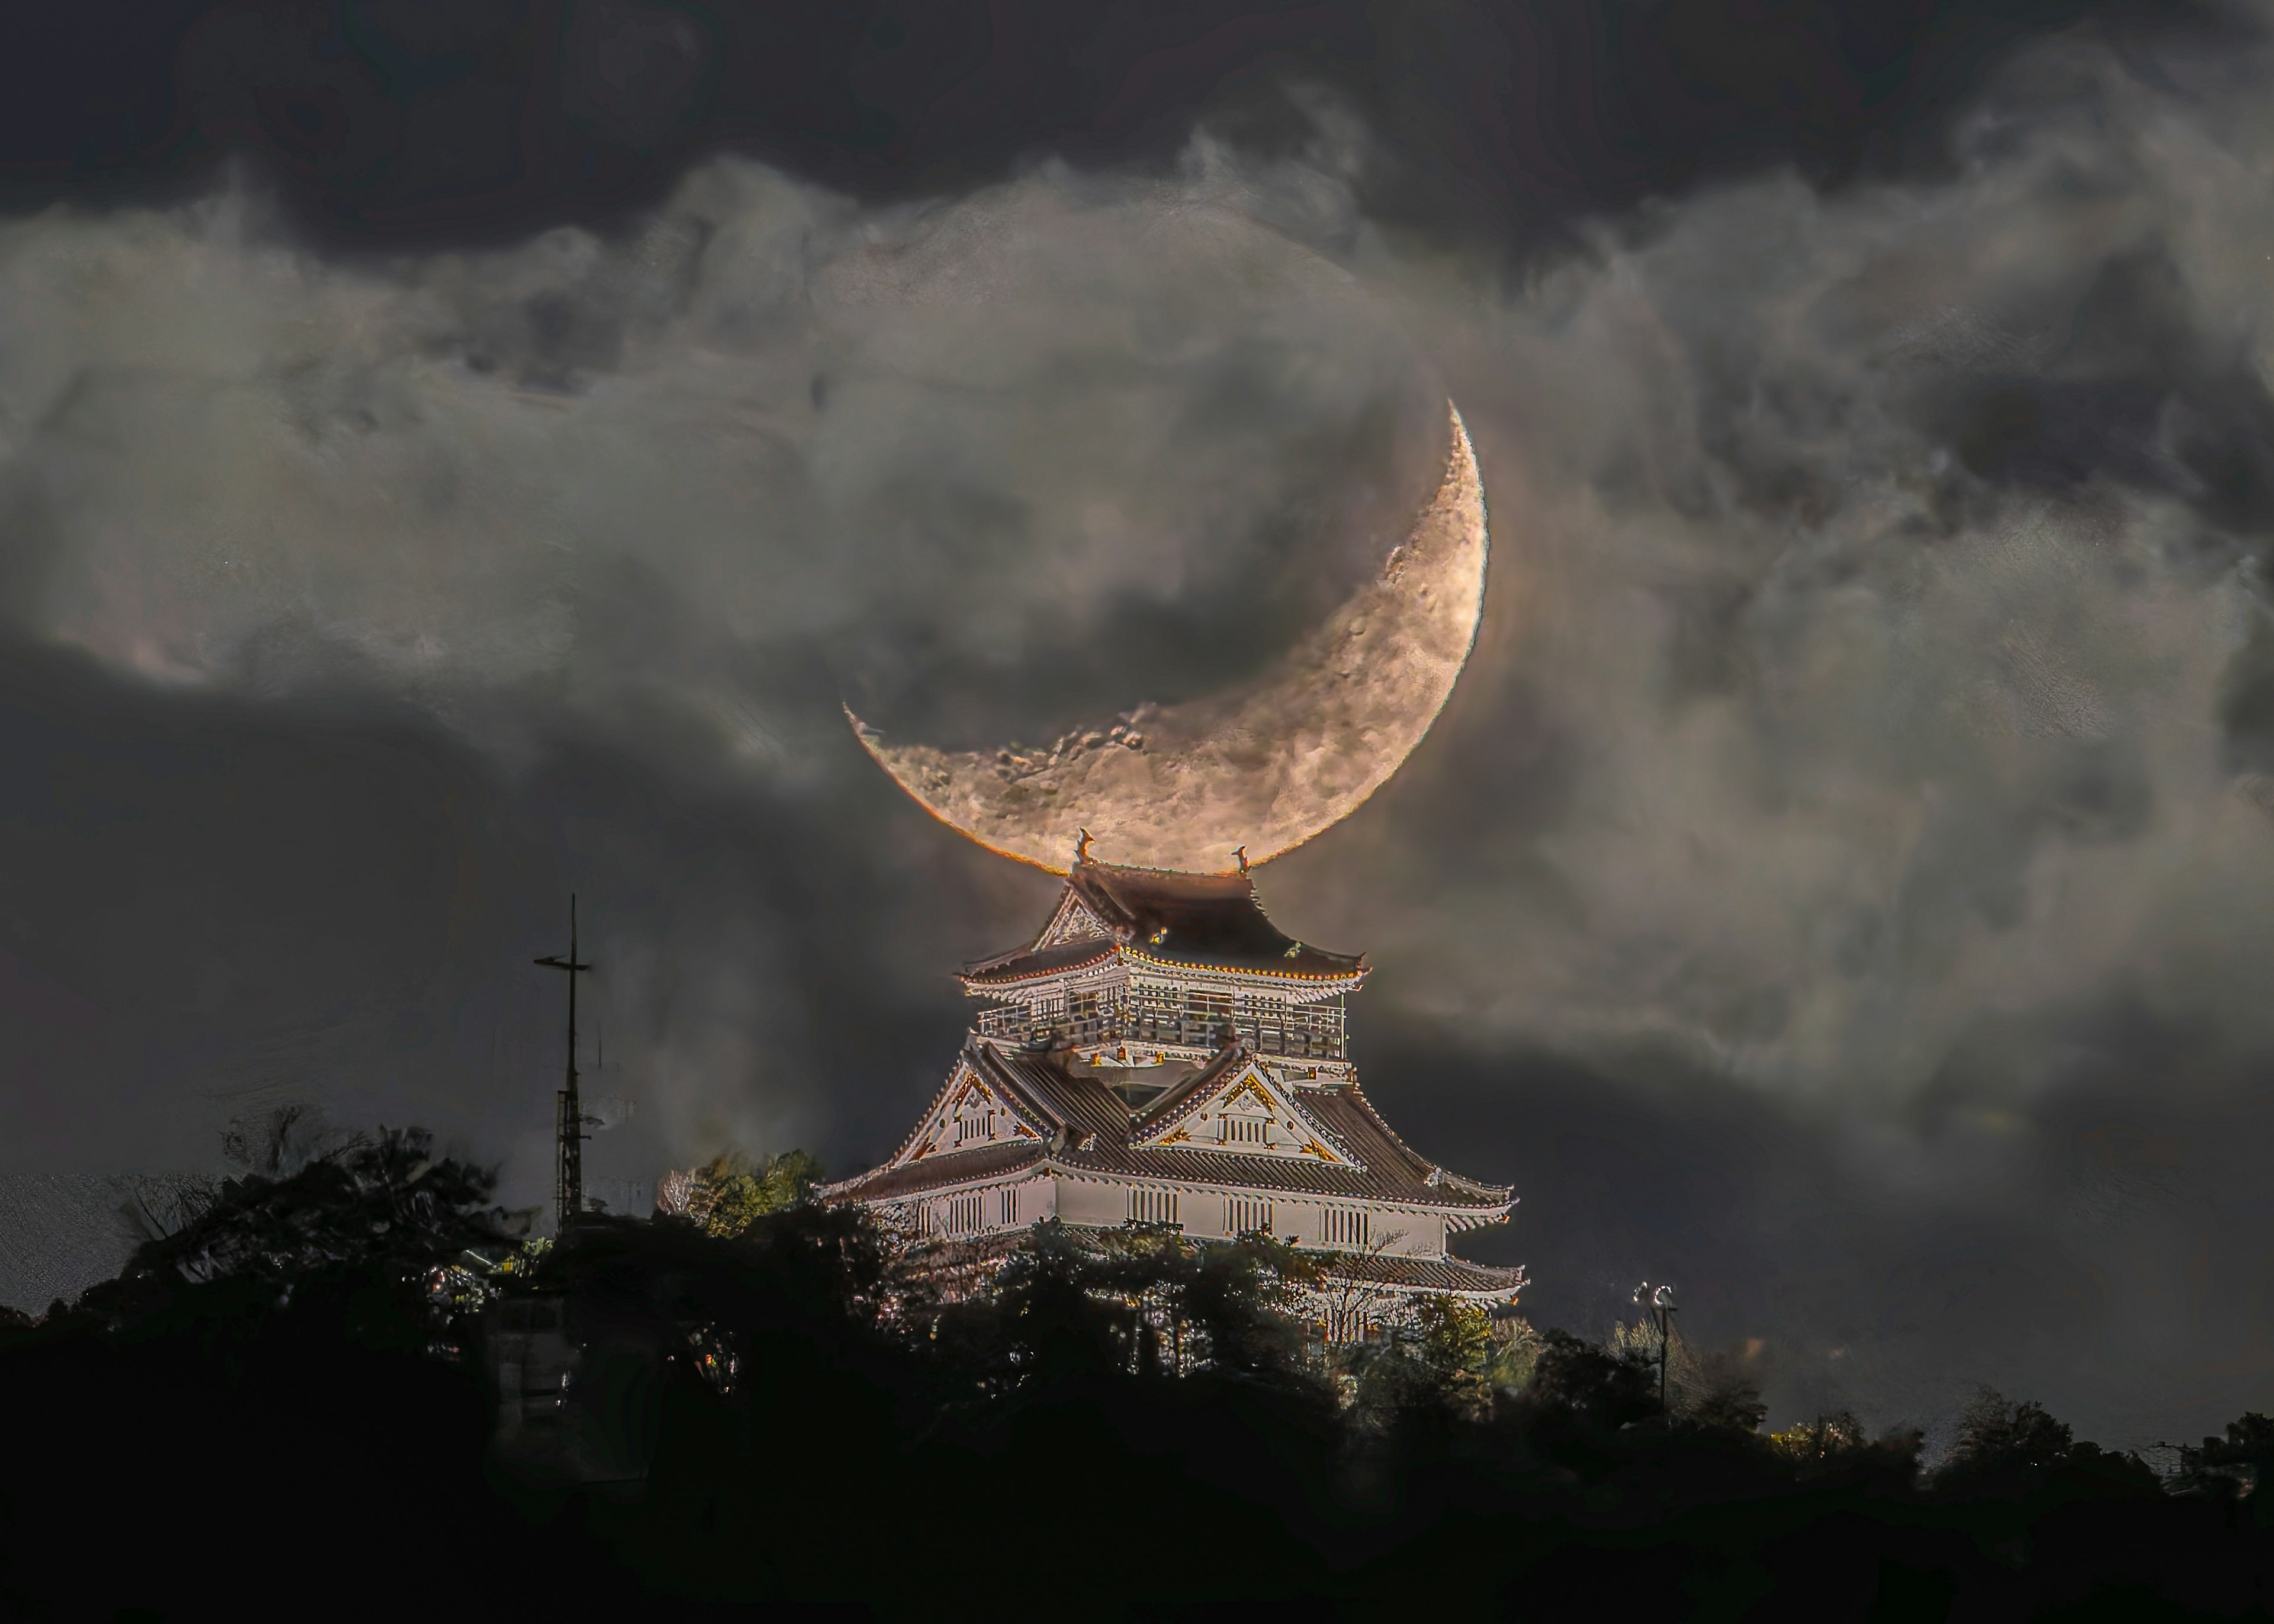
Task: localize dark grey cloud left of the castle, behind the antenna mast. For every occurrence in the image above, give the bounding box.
[0,632,1032,1201]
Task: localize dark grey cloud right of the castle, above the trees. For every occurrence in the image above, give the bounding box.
[1360,1005,2274,1442]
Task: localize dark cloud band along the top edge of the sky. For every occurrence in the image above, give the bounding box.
[0,0,2219,248]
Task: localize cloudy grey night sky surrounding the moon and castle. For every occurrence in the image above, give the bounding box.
[0,0,2274,1445]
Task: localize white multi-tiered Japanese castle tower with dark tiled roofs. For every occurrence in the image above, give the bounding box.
[821,857,1524,1330]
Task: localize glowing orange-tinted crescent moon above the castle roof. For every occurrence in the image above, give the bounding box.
[846,400,1489,873]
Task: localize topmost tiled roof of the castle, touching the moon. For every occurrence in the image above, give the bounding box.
[964,862,1367,985]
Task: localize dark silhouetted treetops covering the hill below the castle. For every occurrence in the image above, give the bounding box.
[0,1130,2237,1617]
